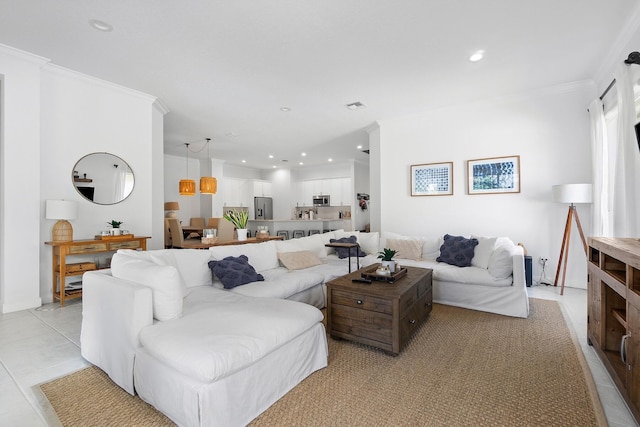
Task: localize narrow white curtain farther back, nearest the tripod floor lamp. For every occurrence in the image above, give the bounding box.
[589,98,611,237]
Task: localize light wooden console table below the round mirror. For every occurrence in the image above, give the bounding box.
[45,236,150,307]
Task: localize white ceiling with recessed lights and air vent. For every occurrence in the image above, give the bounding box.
[0,0,638,168]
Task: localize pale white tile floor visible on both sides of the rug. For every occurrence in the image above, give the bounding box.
[0,286,638,427]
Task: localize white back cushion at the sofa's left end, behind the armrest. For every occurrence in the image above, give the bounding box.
[111,252,183,321]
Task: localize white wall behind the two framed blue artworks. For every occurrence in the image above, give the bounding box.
[370,82,595,288]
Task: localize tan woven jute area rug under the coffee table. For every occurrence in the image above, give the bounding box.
[41,299,606,426]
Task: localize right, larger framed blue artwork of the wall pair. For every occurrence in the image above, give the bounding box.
[467,156,520,194]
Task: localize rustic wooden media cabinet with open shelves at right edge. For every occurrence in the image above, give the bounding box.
[587,237,640,420]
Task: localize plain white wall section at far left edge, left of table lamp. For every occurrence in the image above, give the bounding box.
[0,45,47,313]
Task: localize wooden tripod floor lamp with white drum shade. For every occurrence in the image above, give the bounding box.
[551,184,592,295]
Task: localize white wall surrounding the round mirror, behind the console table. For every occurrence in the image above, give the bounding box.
[40,65,164,301]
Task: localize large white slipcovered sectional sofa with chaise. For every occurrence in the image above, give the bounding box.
[81,231,529,426]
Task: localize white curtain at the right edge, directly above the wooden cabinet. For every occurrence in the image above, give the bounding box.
[613,64,640,237]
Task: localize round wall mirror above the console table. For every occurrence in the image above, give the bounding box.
[71,153,135,205]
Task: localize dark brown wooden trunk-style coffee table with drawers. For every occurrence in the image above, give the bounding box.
[327,267,433,356]
